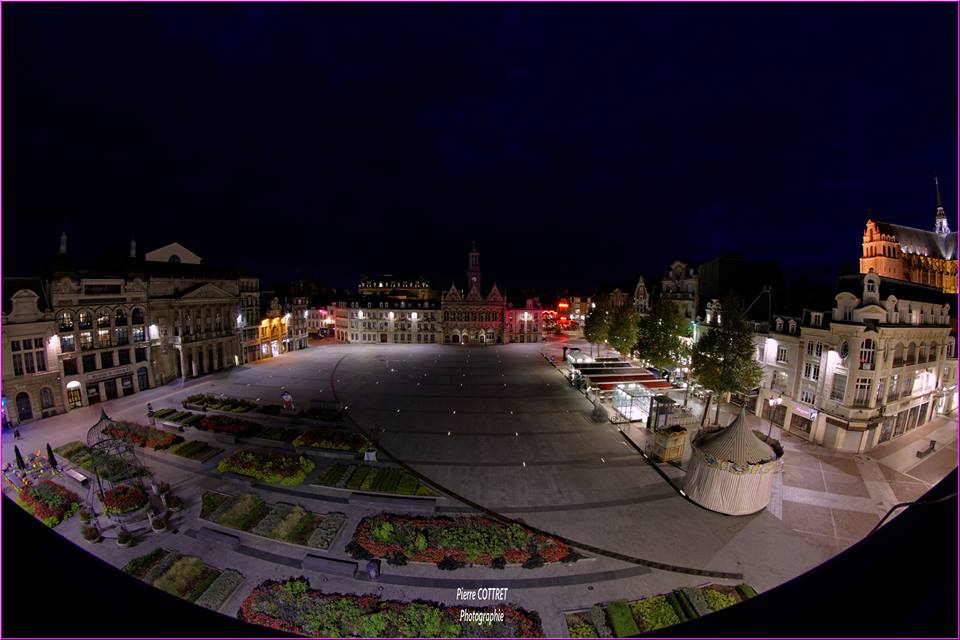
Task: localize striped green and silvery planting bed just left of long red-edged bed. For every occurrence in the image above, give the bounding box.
[200,491,347,549]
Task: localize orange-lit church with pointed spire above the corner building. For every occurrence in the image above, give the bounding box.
[860,178,958,293]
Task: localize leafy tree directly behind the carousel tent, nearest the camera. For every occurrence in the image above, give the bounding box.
[691,295,763,422]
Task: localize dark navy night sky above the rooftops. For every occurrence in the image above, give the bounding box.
[2,3,957,290]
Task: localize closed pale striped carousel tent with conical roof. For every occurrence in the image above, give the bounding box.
[683,409,783,515]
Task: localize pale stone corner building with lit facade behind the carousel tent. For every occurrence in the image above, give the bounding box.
[755,273,957,452]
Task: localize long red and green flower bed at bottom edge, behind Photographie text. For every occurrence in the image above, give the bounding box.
[237,578,543,638]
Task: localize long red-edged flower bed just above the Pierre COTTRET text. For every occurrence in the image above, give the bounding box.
[350,514,573,568]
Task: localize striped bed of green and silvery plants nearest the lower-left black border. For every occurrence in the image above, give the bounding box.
[123,549,243,610]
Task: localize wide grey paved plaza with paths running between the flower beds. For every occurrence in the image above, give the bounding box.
[3,339,957,636]
